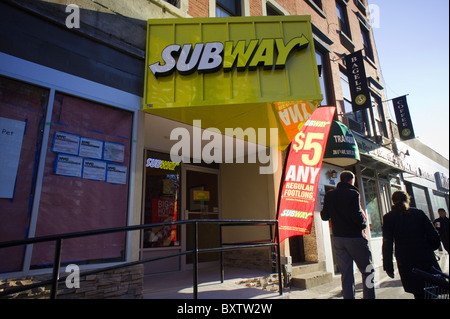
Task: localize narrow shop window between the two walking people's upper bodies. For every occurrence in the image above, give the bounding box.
[363,177,383,237]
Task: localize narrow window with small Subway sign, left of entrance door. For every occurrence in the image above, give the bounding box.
[143,151,181,248]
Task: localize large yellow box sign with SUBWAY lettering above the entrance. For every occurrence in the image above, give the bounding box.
[143,16,322,149]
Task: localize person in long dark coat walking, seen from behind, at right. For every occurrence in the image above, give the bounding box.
[382,191,440,299]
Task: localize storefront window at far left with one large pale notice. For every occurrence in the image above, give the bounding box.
[0,77,49,272]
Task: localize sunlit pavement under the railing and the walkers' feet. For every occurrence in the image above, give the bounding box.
[143,253,449,299]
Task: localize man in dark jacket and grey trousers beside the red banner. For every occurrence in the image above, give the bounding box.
[320,171,375,299]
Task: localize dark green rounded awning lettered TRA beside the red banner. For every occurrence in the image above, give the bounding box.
[323,121,360,167]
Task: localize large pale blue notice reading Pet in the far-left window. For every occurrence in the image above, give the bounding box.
[0,117,25,198]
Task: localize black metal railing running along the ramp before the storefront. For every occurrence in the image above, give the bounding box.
[0,219,283,299]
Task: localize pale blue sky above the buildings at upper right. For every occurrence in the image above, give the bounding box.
[368,0,450,159]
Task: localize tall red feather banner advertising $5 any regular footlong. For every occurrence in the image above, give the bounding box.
[278,107,336,242]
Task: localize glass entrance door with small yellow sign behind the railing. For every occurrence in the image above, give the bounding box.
[183,165,220,264]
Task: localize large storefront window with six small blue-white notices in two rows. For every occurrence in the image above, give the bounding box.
[31,93,133,268]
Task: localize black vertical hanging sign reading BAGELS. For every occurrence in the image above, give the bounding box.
[345,50,372,112]
